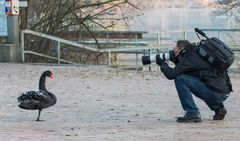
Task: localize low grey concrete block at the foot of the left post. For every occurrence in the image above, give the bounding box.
[0,44,21,63]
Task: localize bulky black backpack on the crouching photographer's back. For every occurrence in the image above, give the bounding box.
[195,28,234,72]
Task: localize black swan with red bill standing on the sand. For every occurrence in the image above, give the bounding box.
[17,71,57,121]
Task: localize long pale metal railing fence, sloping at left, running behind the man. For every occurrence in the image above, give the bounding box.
[21,29,240,68]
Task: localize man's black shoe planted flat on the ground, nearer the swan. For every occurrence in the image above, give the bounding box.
[177,112,202,123]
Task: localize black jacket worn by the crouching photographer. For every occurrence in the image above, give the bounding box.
[161,45,232,94]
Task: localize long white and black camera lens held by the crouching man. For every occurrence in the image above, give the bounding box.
[142,50,176,65]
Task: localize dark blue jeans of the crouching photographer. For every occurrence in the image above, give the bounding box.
[174,74,228,113]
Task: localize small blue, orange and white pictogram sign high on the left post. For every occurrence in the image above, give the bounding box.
[5,0,19,16]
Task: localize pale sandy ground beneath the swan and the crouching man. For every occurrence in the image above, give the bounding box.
[0,63,240,141]
